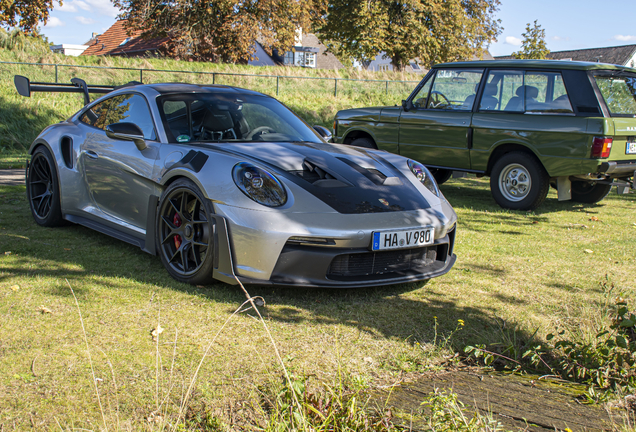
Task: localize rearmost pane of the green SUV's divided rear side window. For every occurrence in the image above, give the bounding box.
[525,72,573,113]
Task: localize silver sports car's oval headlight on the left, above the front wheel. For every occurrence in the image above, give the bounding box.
[232,162,287,207]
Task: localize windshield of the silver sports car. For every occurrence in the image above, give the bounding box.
[158,92,323,143]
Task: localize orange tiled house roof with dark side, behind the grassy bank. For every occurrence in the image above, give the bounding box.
[82,20,168,55]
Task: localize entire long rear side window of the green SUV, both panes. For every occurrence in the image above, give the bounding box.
[479,70,574,114]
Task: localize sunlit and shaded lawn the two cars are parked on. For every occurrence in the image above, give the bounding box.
[0,177,636,430]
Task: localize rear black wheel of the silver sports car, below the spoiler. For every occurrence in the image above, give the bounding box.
[26,146,65,227]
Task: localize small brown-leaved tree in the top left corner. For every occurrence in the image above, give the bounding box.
[0,0,62,36]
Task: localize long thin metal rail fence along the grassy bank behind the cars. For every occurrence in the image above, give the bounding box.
[0,61,419,97]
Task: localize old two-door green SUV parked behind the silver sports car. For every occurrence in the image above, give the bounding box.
[334,60,636,210]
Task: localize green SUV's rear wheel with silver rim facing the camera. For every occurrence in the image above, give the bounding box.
[490,151,550,210]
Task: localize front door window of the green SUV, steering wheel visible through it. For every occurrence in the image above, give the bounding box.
[426,69,484,111]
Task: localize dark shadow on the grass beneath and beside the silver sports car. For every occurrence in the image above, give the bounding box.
[0,186,523,352]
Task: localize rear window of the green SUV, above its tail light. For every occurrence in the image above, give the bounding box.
[594,74,636,117]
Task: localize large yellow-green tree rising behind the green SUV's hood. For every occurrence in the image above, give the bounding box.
[317,0,502,70]
